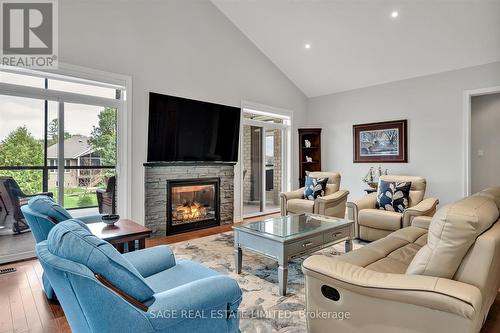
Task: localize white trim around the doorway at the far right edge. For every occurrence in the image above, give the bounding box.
[462,86,500,196]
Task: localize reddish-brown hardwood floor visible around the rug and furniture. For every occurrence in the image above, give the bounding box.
[0,213,500,333]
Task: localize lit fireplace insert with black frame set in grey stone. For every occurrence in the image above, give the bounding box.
[167,178,220,235]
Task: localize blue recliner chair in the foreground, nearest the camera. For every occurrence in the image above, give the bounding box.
[36,219,241,333]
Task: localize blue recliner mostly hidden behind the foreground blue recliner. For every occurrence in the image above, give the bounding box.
[21,195,101,299]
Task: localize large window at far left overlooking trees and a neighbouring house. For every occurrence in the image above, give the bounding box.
[0,71,125,209]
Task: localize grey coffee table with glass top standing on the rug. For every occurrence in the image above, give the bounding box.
[233,214,353,295]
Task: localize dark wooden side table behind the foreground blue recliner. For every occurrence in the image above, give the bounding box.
[87,219,151,253]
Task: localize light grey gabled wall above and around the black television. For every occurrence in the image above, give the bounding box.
[59,0,306,222]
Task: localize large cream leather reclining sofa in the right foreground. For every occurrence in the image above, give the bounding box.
[302,187,500,333]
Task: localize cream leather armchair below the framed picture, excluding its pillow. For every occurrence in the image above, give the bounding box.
[346,175,439,241]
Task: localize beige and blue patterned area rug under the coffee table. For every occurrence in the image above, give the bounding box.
[170,232,362,333]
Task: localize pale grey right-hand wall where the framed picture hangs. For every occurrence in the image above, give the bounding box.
[303,62,500,204]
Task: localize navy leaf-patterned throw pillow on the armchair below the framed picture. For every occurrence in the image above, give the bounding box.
[377,180,411,213]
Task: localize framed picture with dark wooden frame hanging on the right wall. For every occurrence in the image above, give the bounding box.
[352,119,408,163]
